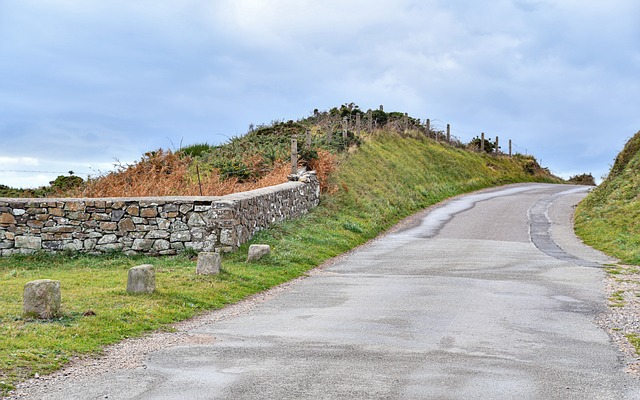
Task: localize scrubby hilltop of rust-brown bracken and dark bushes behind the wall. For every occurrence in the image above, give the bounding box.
[0,104,549,197]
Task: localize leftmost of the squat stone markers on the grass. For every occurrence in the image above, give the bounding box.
[22,279,60,319]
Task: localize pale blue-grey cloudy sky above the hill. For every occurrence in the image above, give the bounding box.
[0,0,640,187]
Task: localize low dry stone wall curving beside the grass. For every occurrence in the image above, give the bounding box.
[0,171,320,256]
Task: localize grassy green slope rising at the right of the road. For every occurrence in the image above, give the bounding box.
[575,132,640,265]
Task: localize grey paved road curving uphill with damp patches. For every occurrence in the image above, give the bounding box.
[20,184,640,399]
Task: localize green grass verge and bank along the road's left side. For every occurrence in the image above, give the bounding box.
[0,134,557,392]
